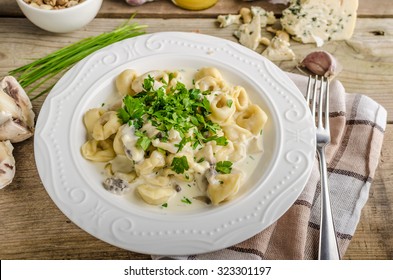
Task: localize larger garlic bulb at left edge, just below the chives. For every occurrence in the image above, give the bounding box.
[0,76,34,143]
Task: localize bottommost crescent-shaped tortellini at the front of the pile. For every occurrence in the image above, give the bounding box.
[136,184,176,205]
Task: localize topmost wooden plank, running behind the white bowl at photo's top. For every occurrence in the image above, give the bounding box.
[0,0,393,18]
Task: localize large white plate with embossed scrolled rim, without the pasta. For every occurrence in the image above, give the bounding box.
[34,32,315,255]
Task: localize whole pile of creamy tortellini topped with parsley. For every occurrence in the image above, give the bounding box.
[81,67,268,207]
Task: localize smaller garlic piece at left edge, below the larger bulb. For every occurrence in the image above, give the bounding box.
[0,140,15,189]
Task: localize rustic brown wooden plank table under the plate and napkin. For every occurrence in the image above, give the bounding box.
[0,0,393,259]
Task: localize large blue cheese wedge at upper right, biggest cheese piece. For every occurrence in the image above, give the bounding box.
[281,0,359,46]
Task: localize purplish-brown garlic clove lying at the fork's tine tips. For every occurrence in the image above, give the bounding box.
[300,51,341,78]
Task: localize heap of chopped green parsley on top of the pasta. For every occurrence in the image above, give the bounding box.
[117,76,228,153]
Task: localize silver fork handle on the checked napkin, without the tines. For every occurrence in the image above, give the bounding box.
[317,147,340,260]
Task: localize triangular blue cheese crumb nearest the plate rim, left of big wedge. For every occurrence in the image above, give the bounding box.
[234,14,261,51]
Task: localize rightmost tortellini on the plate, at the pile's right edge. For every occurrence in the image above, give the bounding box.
[236,104,267,135]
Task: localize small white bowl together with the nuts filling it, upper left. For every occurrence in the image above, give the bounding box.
[16,0,102,33]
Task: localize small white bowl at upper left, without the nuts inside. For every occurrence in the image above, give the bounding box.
[16,0,102,33]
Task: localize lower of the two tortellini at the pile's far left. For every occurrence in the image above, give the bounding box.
[81,139,116,162]
